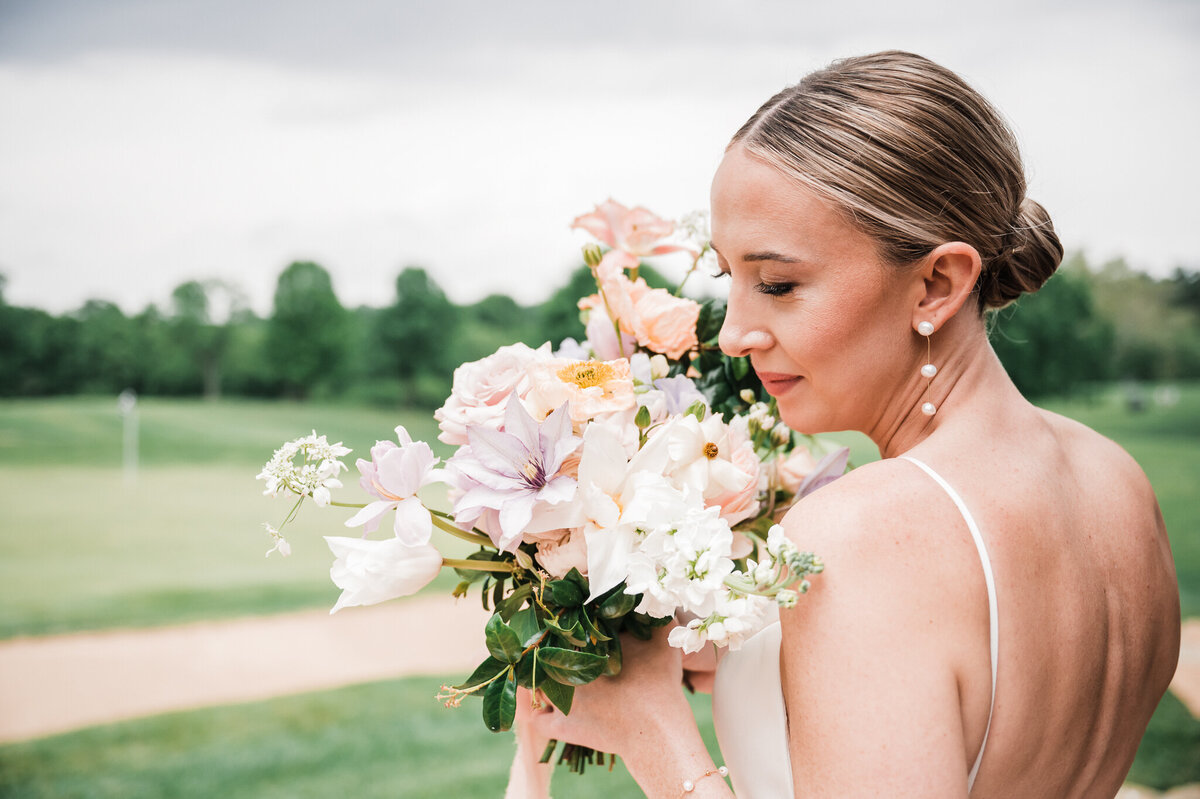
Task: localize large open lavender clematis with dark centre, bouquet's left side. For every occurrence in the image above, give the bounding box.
[446,398,581,552]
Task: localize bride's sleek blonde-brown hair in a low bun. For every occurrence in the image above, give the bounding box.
[730,50,1062,311]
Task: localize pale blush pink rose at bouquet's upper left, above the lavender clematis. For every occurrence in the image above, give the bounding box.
[433,342,553,446]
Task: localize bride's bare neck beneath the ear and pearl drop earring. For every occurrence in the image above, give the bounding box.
[863,314,1019,458]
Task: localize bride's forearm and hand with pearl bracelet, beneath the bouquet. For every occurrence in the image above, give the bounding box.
[518,629,733,799]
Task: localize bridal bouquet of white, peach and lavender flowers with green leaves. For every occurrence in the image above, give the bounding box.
[258,200,847,770]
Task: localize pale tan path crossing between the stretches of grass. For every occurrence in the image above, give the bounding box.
[0,604,1200,743]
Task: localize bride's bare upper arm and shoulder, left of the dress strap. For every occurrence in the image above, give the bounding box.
[781,475,986,799]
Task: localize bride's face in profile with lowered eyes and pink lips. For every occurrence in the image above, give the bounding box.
[712,141,923,433]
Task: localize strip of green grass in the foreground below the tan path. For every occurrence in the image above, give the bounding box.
[0,678,715,799]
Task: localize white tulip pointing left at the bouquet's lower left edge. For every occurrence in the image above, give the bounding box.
[325,535,442,613]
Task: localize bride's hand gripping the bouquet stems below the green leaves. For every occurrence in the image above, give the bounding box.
[517,627,695,761]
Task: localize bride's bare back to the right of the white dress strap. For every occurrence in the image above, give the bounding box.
[945,411,1180,797]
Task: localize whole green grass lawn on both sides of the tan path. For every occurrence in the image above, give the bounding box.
[0,385,1200,799]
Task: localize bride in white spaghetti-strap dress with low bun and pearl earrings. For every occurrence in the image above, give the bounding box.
[510,52,1180,799]
